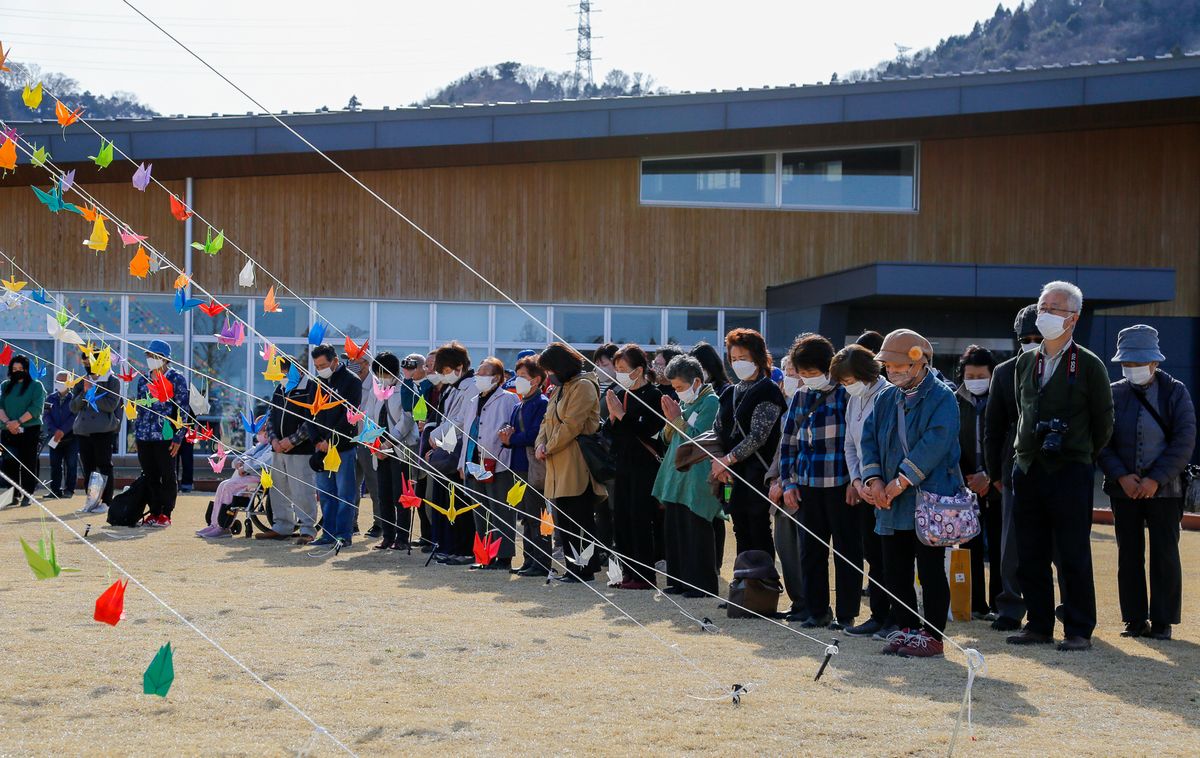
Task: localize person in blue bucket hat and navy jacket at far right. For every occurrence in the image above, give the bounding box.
[1100,324,1196,639]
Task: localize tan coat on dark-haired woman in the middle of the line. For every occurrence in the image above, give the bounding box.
[538,373,607,499]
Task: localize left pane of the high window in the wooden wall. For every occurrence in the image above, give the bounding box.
[642,152,775,205]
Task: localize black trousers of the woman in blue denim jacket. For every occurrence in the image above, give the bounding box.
[880,529,950,638]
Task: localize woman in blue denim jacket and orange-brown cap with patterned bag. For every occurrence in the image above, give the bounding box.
[863,329,962,657]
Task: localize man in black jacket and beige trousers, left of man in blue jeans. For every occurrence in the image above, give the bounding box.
[261,357,317,545]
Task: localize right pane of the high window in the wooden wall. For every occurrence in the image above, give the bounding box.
[780,145,916,211]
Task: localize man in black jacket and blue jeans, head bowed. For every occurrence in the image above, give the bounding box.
[308,344,362,547]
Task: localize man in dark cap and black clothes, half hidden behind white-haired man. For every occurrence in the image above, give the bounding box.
[984,303,1042,632]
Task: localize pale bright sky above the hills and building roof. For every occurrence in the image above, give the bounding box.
[0,0,1016,114]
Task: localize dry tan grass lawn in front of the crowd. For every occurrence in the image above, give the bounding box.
[0,495,1200,756]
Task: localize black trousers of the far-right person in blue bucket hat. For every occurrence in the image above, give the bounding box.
[1111,498,1183,626]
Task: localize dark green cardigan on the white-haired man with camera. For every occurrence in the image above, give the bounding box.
[1015,343,1112,471]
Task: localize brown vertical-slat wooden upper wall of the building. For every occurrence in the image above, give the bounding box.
[0,124,1200,317]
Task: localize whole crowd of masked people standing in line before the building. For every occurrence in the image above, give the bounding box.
[0,282,1196,657]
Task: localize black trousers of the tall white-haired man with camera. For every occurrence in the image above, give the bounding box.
[1013,461,1096,638]
